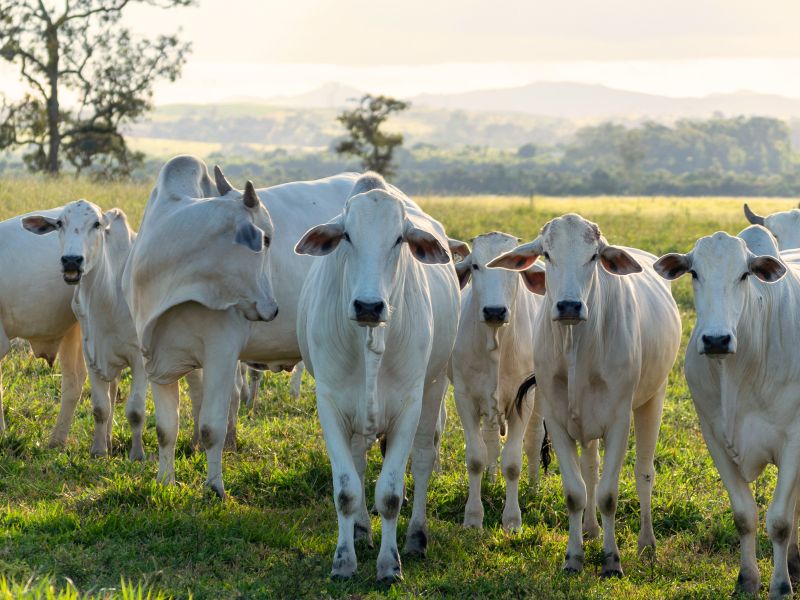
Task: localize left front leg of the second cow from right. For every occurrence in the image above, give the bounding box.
[547,421,586,573]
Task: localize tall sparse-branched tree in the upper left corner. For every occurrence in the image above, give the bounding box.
[0,0,194,175]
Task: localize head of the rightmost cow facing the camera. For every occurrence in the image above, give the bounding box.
[653,231,786,358]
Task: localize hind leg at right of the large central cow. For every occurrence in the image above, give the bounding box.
[406,373,447,556]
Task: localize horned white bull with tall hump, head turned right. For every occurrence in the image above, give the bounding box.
[122,156,278,496]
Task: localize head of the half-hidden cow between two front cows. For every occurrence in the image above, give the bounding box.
[456,231,543,327]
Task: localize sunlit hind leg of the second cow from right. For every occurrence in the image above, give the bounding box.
[633,394,666,553]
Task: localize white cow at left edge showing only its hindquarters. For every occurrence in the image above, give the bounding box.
[0,207,86,447]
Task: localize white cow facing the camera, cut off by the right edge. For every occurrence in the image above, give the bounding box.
[655,232,800,598]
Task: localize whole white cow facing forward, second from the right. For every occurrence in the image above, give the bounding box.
[489,214,681,577]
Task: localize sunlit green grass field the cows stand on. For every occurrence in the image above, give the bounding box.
[0,180,794,599]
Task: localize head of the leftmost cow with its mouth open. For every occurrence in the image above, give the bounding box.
[22,200,116,285]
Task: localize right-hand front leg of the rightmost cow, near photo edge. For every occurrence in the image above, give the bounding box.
[767,450,800,598]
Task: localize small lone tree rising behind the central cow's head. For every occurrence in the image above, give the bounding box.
[336,94,411,176]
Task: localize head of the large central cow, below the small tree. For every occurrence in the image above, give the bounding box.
[295,174,450,327]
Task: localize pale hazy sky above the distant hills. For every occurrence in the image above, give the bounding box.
[0,0,800,104]
